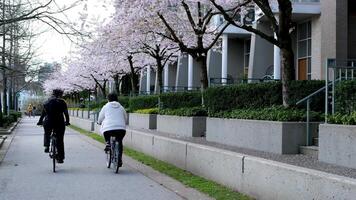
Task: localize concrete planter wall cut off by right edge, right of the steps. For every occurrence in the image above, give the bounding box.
[319,124,356,169]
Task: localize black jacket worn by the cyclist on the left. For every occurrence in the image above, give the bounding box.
[38,97,69,127]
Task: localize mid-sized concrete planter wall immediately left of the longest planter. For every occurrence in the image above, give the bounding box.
[157,115,206,137]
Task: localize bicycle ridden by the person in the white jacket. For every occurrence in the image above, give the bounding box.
[105,136,122,173]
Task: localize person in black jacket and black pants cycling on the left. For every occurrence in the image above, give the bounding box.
[37,89,70,163]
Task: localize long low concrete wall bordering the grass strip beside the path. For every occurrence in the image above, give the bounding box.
[69,122,356,200]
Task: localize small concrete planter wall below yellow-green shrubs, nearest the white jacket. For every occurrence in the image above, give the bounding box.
[129,113,157,129]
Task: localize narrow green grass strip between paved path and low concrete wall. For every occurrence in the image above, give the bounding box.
[70,125,252,200]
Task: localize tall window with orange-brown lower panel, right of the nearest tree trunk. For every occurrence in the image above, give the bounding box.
[297,21,312,80]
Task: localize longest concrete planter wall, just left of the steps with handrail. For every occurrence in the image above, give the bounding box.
[206,118,319,154]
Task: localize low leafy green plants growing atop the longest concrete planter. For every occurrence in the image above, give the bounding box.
[209,106,323,121]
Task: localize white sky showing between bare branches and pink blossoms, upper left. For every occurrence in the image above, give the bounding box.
[34,0,114,62]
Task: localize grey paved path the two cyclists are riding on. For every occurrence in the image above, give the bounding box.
[0,118,182,200]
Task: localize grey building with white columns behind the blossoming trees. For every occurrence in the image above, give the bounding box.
[140,0,356,93]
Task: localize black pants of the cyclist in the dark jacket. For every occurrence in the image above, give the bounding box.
[43,124,65,160]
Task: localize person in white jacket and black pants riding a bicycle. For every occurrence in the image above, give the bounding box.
[98,93,127,165]
